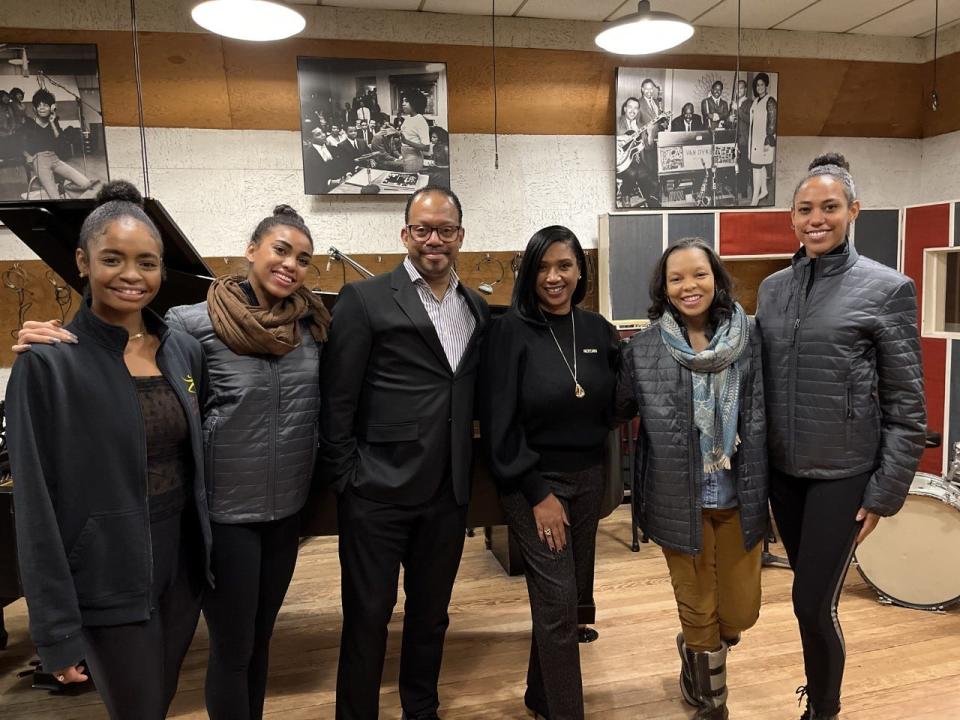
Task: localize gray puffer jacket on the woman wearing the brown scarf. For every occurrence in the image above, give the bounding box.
[166,302,320,524]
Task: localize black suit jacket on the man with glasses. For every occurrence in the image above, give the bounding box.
[320,264,490,505]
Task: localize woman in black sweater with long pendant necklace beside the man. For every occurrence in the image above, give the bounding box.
[479,225,619,720]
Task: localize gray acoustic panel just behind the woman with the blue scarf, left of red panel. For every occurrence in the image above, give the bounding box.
[609,213,664,320]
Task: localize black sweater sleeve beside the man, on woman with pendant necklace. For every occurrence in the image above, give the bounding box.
[479,313,550,506]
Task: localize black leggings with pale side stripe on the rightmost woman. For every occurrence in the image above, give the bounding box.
[770,470,870,715]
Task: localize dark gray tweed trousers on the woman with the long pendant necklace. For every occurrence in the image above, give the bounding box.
[500,466,604,720]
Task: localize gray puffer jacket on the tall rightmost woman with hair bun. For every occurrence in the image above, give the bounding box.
[757,244,926,515]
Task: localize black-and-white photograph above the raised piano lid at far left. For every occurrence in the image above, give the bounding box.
[0,42,109,202]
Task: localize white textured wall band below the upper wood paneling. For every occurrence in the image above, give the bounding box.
[0,128,924,260]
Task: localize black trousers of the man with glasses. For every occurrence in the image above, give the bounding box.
[337,482,467,720]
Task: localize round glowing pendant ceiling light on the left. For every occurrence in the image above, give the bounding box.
[190,0,307,42]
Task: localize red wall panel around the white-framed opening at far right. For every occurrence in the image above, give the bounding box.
[903,203,951,475]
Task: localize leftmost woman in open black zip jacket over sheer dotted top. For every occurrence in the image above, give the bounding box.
[7,182,210,720]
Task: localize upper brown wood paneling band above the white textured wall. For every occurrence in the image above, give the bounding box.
[0,28,960,138]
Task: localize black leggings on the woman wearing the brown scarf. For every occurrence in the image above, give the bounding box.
[203,515,300,720]
